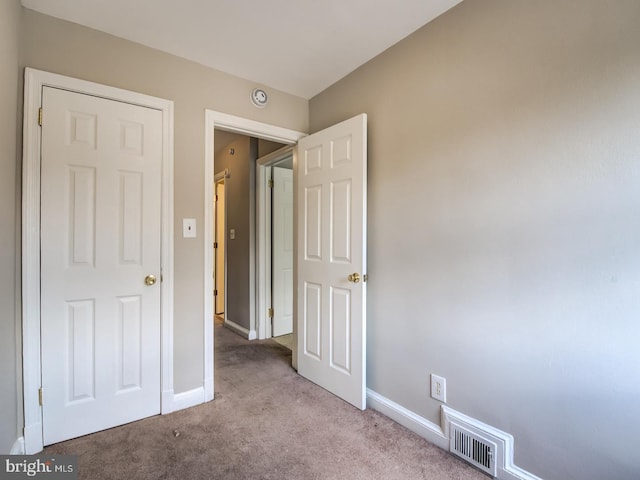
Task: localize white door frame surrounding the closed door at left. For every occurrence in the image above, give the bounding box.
[22,68,174,454]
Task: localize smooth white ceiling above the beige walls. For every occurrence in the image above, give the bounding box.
[22,0,461,99]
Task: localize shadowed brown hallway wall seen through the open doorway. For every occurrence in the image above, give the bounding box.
[215,135,258,330]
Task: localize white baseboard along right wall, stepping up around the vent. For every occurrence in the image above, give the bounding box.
[367,389,542,480]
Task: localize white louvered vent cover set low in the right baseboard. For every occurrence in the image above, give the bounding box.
[449,421,496,477]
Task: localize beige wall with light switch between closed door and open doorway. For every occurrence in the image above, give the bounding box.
[20,10,308,392]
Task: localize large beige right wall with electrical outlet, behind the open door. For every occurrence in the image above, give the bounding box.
[310,0,640,480]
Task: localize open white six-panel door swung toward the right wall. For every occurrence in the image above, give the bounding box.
[297,114,367,409]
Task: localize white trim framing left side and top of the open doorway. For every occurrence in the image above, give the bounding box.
[203,110,306,401]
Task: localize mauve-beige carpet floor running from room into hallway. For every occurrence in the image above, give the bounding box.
[45,324,489,480]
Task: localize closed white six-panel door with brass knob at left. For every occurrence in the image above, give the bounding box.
[41,87,162,445]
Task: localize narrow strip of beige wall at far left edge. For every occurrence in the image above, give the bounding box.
[0,0,22,454]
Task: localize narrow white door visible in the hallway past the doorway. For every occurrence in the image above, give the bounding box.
[272,167,293,337]
